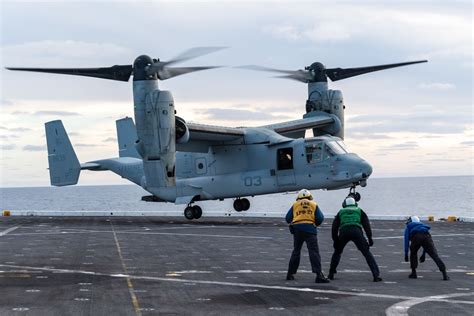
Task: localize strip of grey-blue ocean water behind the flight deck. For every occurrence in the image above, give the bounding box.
[0,176,474,218]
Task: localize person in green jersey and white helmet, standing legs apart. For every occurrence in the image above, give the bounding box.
[328,196,382,282]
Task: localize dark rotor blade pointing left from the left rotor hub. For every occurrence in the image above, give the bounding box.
[6,65,133,81]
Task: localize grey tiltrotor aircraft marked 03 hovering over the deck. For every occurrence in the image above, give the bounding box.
[8,47,426,219]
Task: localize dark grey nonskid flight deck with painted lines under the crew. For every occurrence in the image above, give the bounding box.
[0,217,474,315]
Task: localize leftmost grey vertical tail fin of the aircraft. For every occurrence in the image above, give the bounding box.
[44,120,81,186]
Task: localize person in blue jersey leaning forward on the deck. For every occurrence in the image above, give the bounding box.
[404,216,449,281]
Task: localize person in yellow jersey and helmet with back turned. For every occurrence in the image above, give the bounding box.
[286,189,329,283]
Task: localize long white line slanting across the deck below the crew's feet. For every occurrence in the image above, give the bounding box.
[0,264,474,305]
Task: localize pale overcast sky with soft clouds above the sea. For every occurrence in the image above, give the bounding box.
[0,0,474,187]
